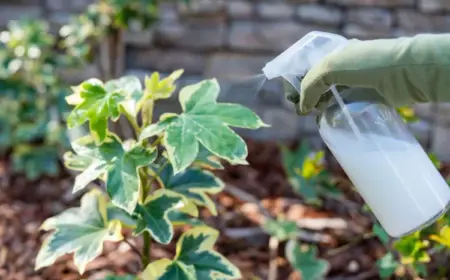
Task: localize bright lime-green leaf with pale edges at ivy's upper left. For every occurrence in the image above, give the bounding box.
[67,79,127,143]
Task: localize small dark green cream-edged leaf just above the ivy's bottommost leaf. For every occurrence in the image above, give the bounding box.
[136,189,184,244]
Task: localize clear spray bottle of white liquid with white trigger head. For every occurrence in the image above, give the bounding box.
[263,31,450,238]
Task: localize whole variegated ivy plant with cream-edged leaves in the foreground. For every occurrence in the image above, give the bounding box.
[36,70,265,280]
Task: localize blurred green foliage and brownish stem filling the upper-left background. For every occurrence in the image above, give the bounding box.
[0,0,185,180]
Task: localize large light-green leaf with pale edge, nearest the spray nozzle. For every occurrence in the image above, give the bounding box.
[142,80,266,173]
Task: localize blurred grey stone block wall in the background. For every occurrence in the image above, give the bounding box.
[0,0,450,160]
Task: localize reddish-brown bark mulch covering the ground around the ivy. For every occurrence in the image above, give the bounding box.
[0,141,446,280]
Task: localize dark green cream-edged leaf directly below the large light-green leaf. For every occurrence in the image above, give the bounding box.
[153,164,224,215]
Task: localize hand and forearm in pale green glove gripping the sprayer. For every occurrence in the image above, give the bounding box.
[290,34,450,113]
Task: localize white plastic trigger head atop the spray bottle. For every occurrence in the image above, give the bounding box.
[262,31,347,92]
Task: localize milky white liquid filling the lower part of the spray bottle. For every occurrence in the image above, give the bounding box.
[321,129,450,237]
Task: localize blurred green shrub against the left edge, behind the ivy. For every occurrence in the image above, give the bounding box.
[0,20,68,179]
